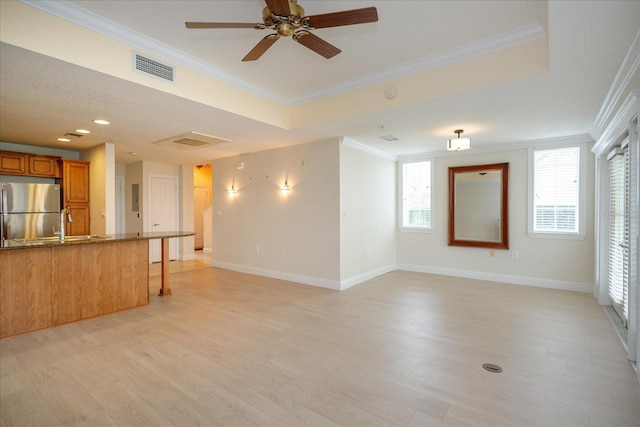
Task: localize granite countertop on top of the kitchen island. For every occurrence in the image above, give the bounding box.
[0,231,195,250]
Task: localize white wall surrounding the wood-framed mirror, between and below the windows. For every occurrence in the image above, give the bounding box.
[397,145,595,292]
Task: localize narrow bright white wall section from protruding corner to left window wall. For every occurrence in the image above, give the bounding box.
[340,142,396,289]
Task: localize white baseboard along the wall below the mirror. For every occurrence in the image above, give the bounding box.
[397,264,593,293]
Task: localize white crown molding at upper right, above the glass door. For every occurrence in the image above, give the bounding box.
[591,30,640,142]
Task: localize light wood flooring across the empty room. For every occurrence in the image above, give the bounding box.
[0,262,640,427]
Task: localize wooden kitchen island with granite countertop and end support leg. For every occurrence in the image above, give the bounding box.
[0,232,193,338]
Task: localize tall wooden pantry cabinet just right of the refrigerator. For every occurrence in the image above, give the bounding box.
[61,159,91,236]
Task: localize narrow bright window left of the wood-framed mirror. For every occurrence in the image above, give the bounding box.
[400,160,433,229]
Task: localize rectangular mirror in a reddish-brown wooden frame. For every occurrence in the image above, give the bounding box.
[449,163,509,249]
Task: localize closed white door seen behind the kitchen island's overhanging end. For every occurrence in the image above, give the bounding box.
[147,175,180,262]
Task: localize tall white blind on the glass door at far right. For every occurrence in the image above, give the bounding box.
[609,148,629,321]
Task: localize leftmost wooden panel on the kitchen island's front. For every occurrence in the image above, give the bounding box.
[0,248,51,337]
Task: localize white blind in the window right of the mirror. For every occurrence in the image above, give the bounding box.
[533,146,580,233]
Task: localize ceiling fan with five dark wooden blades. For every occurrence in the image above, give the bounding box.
[185,0,378,61]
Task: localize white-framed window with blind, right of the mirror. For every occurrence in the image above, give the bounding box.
[528,144,586,238]
